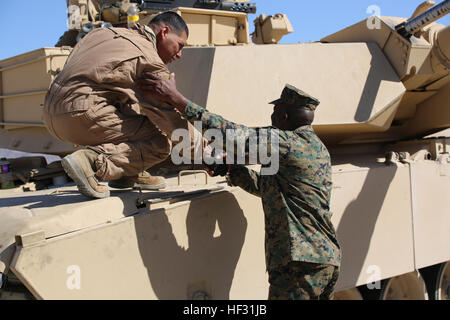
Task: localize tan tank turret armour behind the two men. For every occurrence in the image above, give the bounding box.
[0,13,450,154]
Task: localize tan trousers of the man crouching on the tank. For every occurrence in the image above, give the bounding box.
[43,94,205,181]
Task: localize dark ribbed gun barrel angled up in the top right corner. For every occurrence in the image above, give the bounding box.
[396,0,450,38]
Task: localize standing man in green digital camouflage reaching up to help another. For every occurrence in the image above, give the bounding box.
[140,73,341,300]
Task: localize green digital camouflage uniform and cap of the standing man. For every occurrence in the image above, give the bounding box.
[185,85,341,299]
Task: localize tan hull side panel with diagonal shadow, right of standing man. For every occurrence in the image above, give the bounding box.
[331,159,414,288]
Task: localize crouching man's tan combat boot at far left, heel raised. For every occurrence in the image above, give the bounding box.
[61,149,109,199]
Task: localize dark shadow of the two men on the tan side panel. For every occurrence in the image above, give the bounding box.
[135,192,247,299]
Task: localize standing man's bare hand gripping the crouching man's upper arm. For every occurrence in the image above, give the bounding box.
[137,72,188,112]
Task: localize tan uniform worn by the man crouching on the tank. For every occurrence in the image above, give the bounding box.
[43,25,202,181]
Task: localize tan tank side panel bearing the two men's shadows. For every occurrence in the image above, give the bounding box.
[11,182,267,299]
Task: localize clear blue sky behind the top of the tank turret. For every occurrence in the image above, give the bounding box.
[0,0,450,60]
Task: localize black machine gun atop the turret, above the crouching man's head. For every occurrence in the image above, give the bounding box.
[137,0,256,13]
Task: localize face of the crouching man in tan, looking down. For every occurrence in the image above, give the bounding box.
[156,26,187,64]
